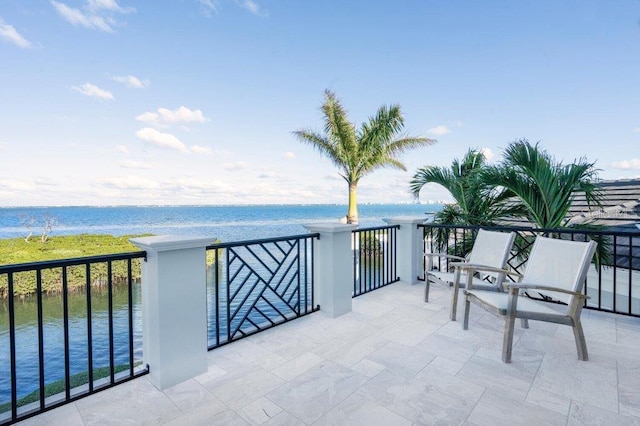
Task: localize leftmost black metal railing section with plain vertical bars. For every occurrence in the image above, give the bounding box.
[0,252,148,424]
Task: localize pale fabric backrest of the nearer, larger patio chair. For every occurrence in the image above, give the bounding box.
[521,237,598,304]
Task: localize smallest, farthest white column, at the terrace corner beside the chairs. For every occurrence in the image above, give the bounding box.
[382,216,427,285]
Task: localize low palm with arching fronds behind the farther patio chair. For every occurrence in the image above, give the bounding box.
[410,149,520,226]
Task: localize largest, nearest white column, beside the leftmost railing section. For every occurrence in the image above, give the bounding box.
[130,235,215,390]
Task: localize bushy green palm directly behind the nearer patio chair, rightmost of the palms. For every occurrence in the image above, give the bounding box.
[480,139,602,228]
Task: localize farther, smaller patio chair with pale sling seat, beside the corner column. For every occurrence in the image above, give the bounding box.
[424,229,516,321]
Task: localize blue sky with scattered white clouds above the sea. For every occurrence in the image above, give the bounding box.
[0,0,640,206]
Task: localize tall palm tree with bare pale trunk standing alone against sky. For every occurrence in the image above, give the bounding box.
[293,90,435,223]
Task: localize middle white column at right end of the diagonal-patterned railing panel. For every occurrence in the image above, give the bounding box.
[305,223,357,318]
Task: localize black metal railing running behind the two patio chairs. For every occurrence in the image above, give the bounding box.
[418,224,640,316]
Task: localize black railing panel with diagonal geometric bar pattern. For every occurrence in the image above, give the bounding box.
[207,234,320,350]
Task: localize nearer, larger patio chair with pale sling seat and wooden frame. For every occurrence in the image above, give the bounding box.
[463,237,597,363]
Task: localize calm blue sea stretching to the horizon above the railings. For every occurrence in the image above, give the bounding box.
[0,204,441,242]
